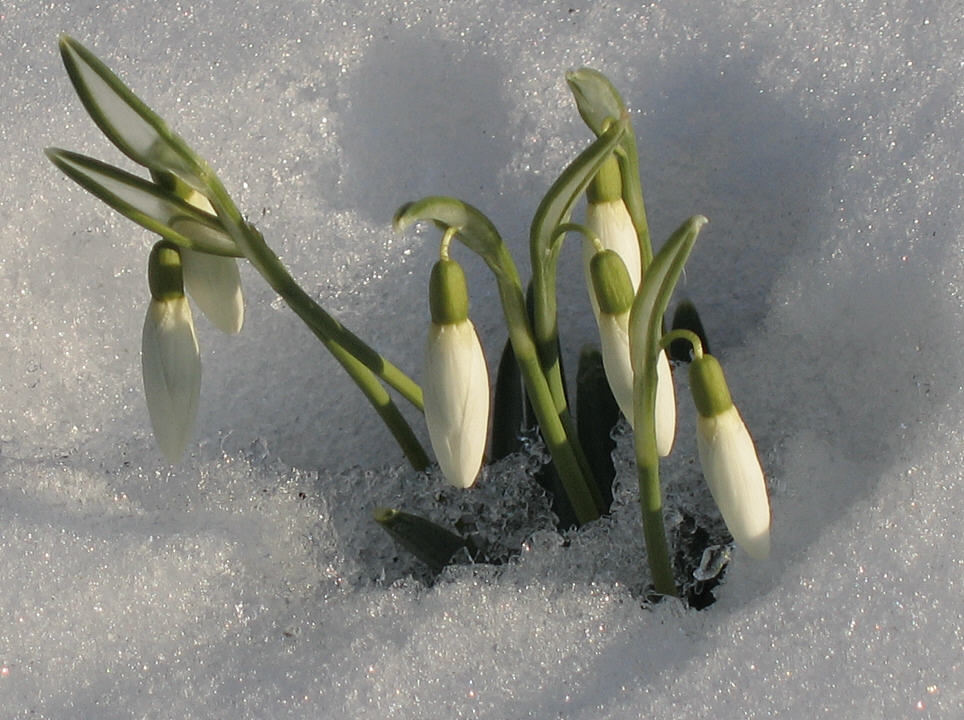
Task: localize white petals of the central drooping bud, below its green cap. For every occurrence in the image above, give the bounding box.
[423,320,489,488]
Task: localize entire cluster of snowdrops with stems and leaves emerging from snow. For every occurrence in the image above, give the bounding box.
[47,37,770,595]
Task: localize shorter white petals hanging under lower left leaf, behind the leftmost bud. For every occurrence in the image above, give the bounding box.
[180,248,244,335]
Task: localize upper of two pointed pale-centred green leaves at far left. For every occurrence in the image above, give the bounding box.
[60,35,206,190]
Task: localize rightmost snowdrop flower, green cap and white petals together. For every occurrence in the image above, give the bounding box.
[690,355,770,560]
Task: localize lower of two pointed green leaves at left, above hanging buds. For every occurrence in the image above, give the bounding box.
[45,148,242,257]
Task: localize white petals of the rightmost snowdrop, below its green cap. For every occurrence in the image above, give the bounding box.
[696,406,770,560]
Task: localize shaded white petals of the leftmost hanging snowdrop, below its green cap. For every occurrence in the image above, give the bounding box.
[141,296,201,463]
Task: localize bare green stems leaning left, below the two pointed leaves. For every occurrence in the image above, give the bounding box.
[205,173,429,470]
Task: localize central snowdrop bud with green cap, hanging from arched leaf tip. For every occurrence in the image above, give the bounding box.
[422,256,489,488]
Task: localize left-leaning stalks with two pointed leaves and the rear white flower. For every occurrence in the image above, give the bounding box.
[46,35,428,469]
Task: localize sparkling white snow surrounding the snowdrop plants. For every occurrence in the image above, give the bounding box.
[0,0,964,719]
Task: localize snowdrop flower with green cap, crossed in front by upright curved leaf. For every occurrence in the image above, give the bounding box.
[589,250,676,457]
